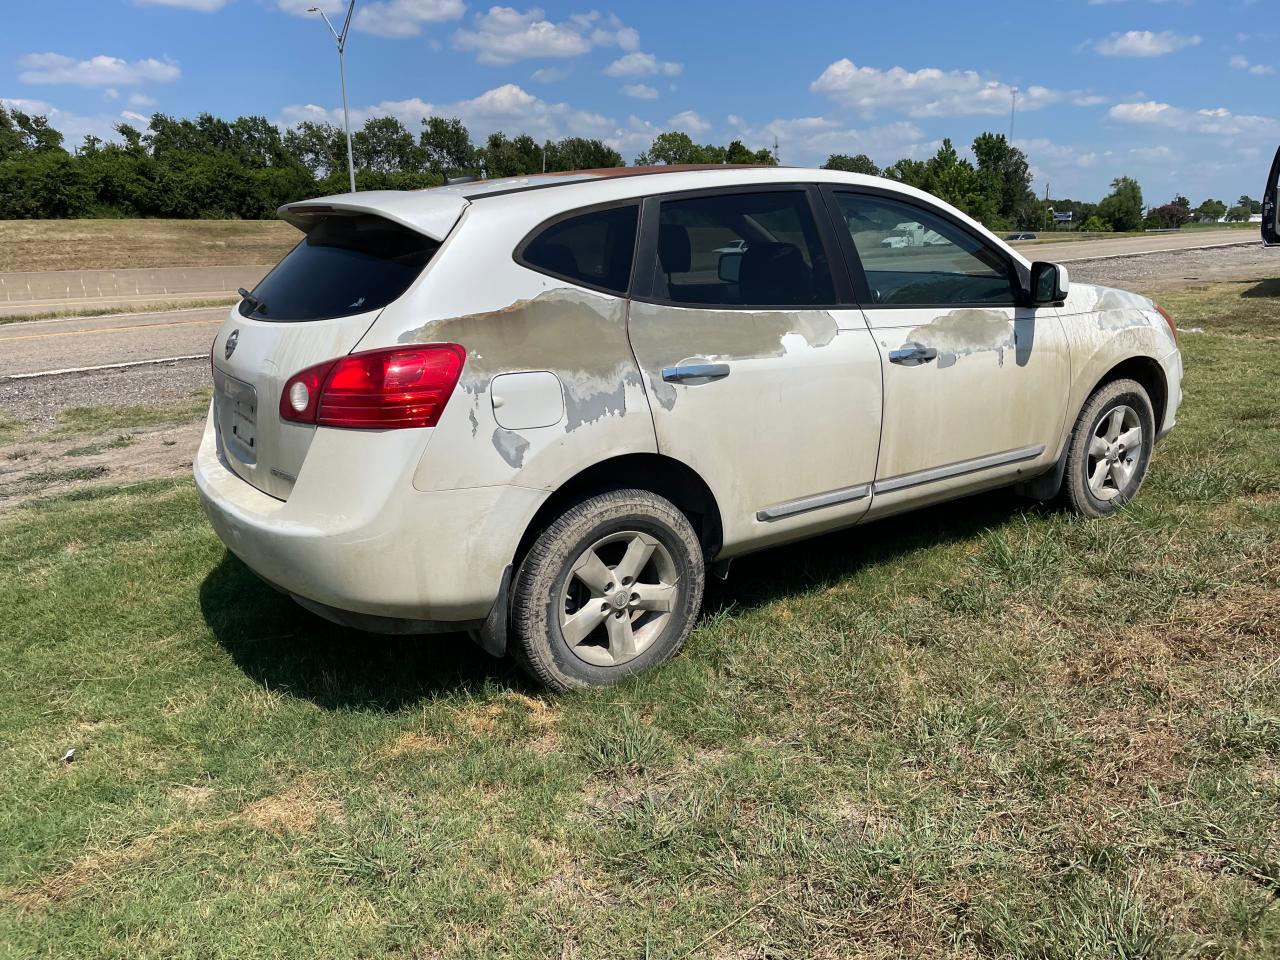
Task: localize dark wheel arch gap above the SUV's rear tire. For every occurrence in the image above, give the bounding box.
[515,453,723,566]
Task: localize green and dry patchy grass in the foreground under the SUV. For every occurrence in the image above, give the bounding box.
[0,282,1280,960]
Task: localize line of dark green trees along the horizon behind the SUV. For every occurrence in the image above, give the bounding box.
[0,105,1261,230]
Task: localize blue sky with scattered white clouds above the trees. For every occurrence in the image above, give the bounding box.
[0,0,1280,204]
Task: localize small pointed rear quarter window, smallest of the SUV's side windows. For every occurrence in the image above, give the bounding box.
[517,204,640,294]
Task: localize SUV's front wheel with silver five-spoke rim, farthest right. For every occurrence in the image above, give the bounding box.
[1064,380,1156,517]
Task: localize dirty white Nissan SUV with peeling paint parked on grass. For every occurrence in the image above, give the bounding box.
[195,168,1181,690]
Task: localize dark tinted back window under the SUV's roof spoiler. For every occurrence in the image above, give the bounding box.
[239,214,440,323]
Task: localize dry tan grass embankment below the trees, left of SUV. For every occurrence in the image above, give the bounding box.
[0,220,300,273]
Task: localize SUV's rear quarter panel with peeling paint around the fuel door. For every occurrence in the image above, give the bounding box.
[350,204,657,496]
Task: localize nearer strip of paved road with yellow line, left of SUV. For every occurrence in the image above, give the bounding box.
[0,307,228,378]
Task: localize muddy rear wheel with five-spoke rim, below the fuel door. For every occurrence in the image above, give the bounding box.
[511,490,707,691]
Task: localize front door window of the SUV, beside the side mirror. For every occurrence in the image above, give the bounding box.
[836,193,1019,306]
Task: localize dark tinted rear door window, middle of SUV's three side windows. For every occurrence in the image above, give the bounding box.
[654,189,836,307]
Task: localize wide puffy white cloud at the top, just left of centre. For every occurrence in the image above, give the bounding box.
[453,6,640,65]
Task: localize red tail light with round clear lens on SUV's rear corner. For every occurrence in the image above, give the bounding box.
[280,343,467,430]
